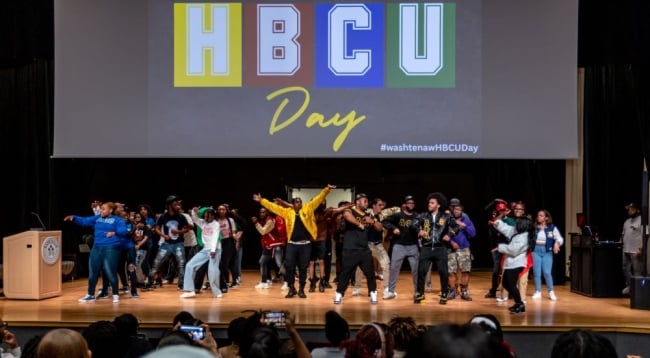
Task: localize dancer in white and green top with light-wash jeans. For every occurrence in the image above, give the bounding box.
[181,207,223,298]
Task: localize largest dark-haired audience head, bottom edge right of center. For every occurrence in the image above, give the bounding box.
[405,323,512,358]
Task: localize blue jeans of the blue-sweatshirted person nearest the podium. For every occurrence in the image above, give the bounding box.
[88,245,121,296]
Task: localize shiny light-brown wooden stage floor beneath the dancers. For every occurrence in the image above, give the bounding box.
[0,271,650,334]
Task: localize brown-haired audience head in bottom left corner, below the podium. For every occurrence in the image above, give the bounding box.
[36,328,91,358]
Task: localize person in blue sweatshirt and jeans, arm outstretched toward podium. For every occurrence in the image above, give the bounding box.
[63,202,127,303]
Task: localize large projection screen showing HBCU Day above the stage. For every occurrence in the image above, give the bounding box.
[53,0,578,159]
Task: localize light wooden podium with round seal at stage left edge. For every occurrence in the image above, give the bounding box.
[2,230,61,300]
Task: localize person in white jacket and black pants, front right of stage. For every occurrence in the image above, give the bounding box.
[491,216,535,313]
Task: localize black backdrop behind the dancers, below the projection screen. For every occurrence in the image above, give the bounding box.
[41,159,564,267]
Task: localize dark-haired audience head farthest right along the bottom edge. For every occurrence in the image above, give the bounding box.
[551,329,617,358]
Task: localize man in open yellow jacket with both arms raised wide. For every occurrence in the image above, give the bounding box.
[253,184,336,298]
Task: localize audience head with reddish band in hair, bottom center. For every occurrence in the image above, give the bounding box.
[341,323,395,358]
